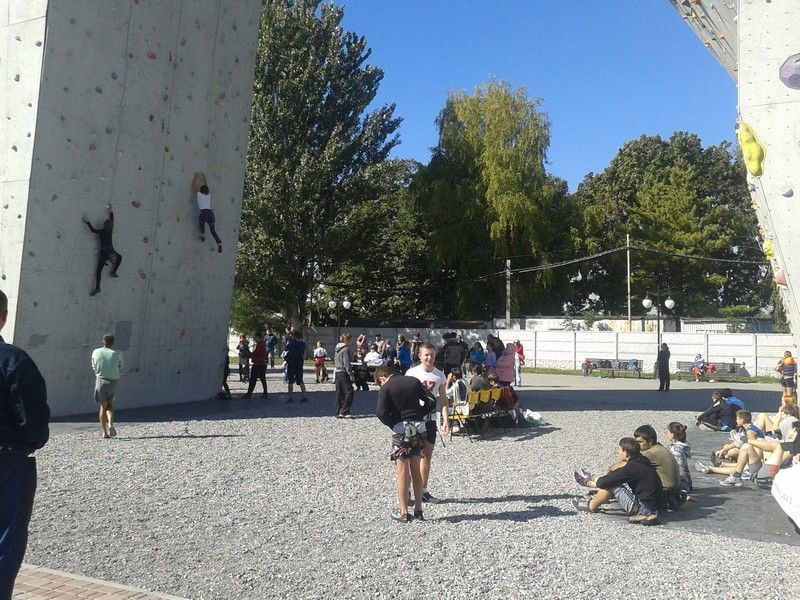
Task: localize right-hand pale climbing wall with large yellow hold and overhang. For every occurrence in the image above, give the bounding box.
[671,0,800,345]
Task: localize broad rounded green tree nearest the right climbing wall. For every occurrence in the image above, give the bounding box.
[574,132,770,316]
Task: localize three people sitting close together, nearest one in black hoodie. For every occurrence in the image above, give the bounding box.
[573,422,692,525]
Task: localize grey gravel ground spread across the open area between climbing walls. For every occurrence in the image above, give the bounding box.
[26,377,800,599]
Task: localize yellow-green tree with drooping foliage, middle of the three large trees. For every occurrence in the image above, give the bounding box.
[412,81,569,318]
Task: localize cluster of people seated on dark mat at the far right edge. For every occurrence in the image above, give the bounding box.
[695,390,800,487]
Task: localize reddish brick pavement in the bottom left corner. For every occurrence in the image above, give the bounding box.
[12,564,182,600]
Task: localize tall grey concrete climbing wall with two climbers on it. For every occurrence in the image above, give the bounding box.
[0,0,261,415]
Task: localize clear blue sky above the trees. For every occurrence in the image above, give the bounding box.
[337,0,736,190]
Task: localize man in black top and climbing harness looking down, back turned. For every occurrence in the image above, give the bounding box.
[375,365,436,523]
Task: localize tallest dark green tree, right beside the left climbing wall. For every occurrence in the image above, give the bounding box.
[236,0,400,323]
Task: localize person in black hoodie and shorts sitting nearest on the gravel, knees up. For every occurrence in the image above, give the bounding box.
[572,438,667,525]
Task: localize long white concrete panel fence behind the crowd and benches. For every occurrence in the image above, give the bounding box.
[230,327,798,377]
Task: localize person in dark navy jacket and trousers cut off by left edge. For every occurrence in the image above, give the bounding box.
[0,291,50,599]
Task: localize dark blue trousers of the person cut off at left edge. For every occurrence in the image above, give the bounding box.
[0,452,36,600]
